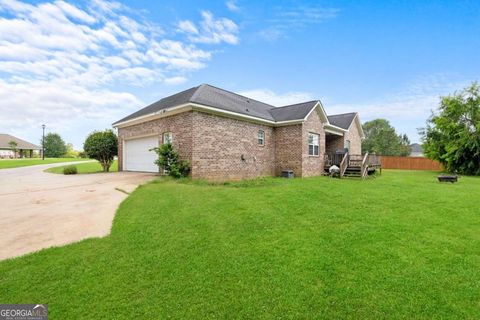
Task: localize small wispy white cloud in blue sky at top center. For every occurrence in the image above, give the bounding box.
[178,11,239,44]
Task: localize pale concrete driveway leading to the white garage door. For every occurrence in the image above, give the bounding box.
[0,163,155,259]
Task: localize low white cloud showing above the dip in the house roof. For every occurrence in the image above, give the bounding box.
[239,89,315,107]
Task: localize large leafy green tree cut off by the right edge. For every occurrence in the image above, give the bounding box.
[420,82,480,175]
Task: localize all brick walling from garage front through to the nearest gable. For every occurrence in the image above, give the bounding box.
[118,111,340,180]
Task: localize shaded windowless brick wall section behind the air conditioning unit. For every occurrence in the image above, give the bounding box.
[275,124,303,177]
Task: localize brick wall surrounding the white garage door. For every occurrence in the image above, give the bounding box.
[118,112,193,170]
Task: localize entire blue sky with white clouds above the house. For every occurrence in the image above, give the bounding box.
[0,0,480,149]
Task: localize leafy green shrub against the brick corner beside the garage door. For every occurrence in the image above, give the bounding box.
[152,143,190,178]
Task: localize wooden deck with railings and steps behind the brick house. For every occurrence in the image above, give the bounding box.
[325,152,382,179]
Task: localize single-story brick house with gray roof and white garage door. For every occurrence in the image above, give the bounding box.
[113,84,363,180]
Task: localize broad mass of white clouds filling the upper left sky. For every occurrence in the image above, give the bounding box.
[0,0,238,146]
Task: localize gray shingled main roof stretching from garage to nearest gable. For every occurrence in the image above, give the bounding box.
[114,84,326,125]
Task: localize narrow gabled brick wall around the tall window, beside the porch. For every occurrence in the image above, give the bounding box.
[301,110,325,177]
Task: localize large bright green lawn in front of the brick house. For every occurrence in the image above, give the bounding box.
[0,170,480,319]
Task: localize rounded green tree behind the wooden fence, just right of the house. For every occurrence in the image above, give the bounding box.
[362,119,410,156]
